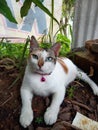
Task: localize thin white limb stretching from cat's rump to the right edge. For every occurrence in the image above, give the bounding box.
[77,69,98,95]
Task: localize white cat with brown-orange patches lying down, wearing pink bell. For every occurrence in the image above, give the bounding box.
[20,36,98,128]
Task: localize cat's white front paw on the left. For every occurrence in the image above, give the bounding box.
[20,110,33,128]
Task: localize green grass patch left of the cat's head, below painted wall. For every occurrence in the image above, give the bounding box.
[0,40,29,67]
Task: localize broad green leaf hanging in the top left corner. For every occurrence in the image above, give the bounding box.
[0,0,17,23]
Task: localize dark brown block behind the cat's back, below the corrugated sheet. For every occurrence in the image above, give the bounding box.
[69,48,98,83]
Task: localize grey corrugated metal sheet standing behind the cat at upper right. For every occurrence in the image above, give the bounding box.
[72,0,98,48]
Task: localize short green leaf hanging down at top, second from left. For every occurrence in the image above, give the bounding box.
[20,0,32,18]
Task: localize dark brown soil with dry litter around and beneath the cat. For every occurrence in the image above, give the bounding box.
[0,62,98,130]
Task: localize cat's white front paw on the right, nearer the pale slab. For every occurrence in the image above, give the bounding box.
[44,108,58,125]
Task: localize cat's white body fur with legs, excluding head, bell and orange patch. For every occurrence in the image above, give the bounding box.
[20,58,98,128]
